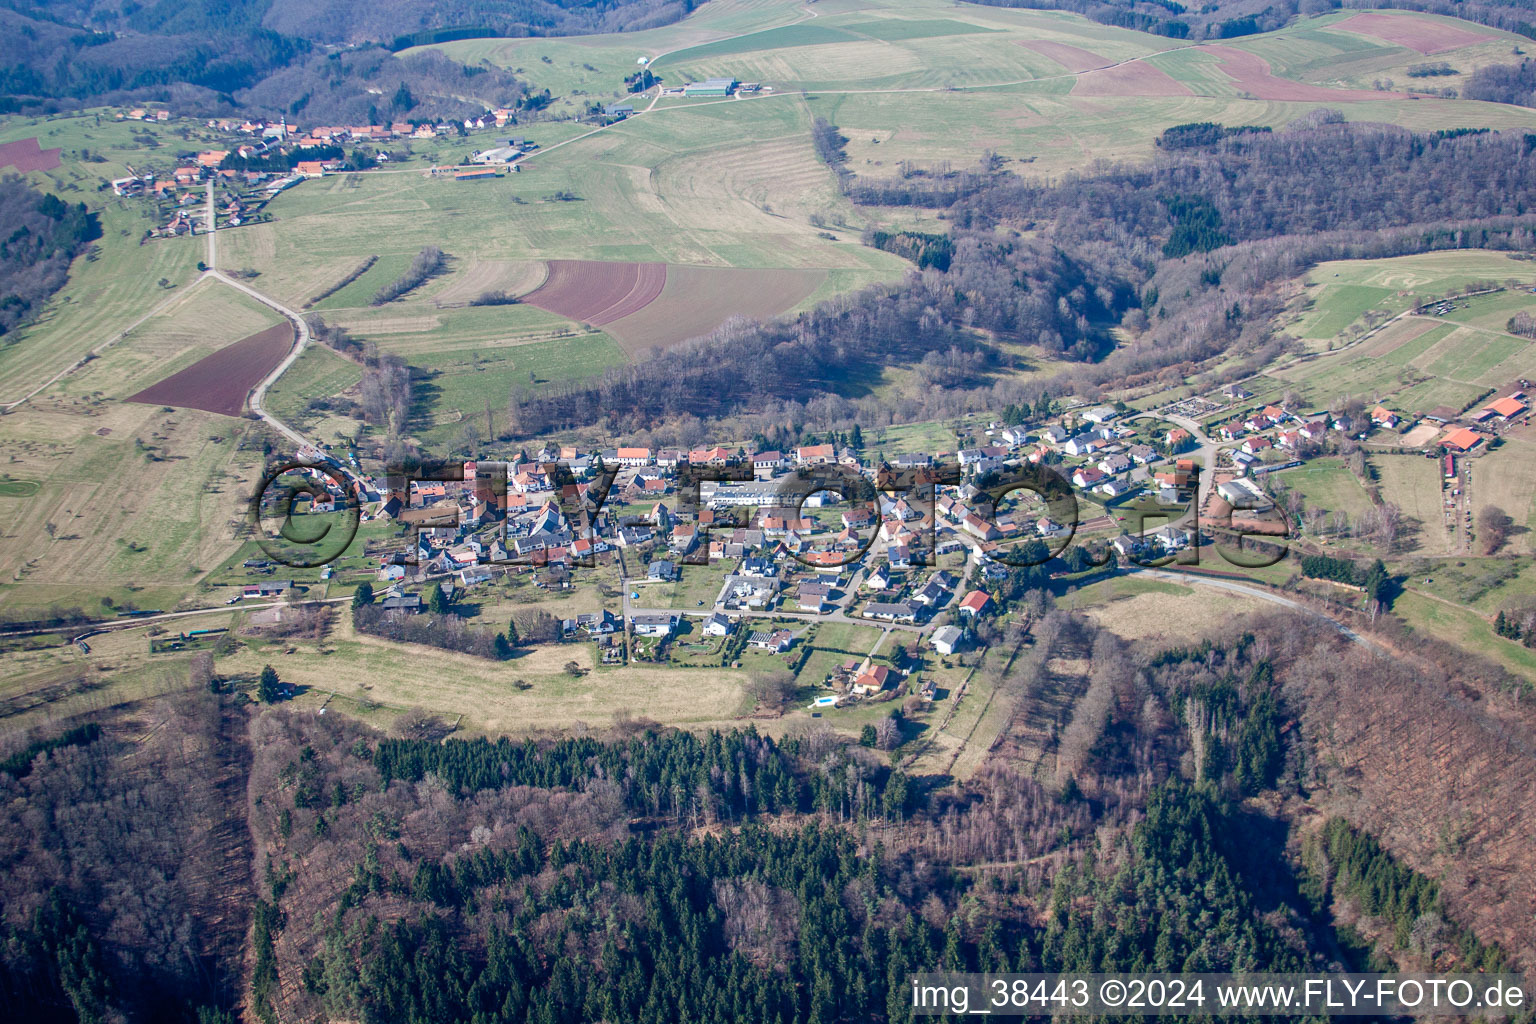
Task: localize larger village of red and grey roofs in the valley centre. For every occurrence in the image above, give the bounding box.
[232,360,1530,712]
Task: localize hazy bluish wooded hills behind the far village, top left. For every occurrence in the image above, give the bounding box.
[0,0,694,117]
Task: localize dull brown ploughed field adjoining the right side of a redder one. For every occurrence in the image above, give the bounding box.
[607,266,826,356]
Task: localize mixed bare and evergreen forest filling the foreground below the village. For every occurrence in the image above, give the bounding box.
[0,611,1536,1022]
